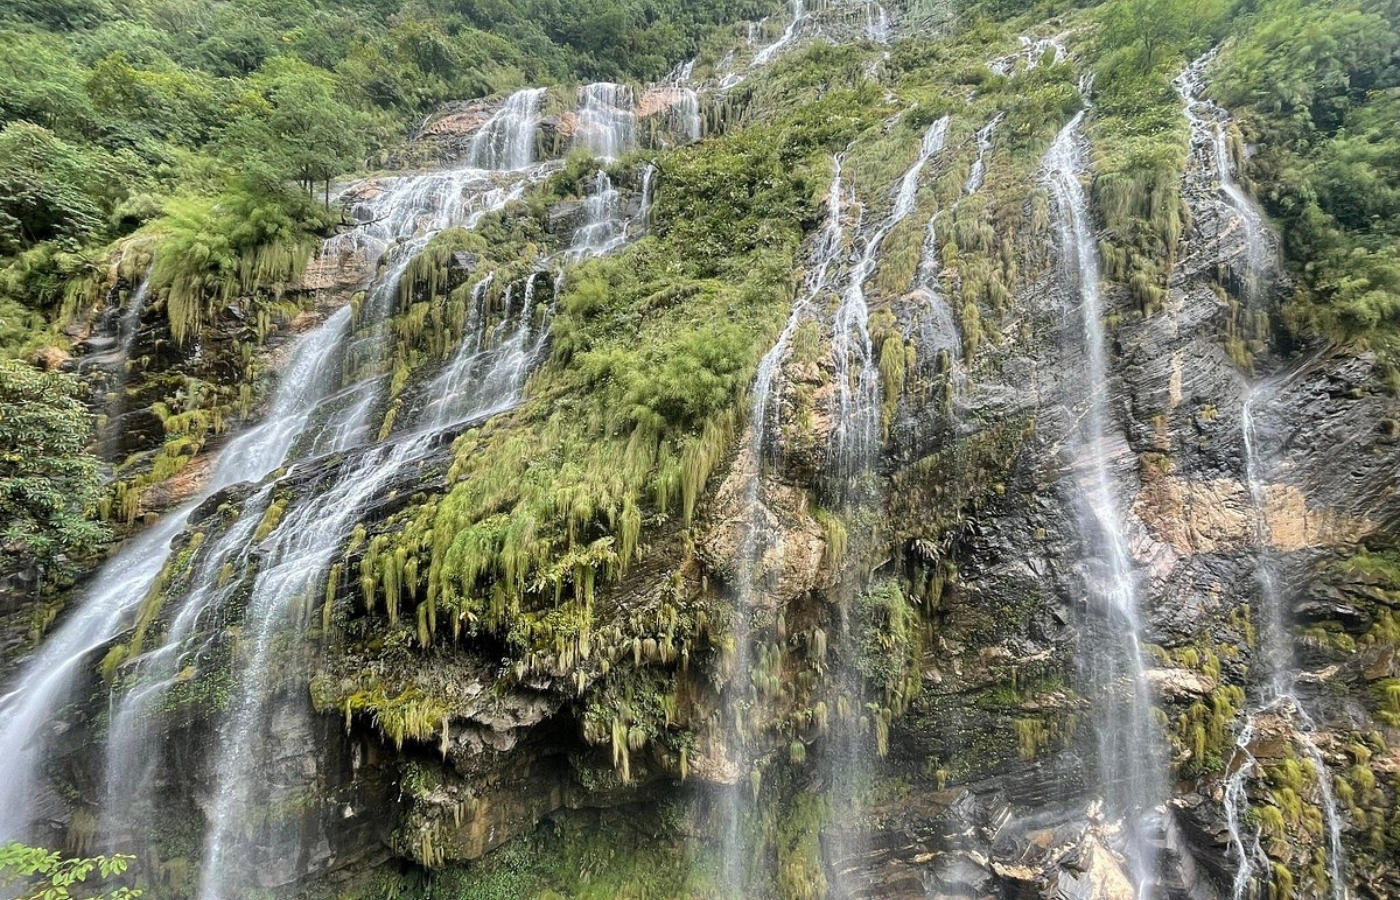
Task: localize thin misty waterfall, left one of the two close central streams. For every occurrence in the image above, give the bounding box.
[720,157,841,899]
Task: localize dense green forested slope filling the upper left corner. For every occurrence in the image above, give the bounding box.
[0,0,769,354]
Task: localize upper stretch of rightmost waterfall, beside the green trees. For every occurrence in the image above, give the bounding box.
[1173,50,1273,302]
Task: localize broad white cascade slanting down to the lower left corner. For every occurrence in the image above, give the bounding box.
[0,86,557,858]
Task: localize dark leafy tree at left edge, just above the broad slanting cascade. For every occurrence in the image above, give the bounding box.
[0,360,106,585]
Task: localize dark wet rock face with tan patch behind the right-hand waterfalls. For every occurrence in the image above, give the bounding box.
[812,80,1400,897]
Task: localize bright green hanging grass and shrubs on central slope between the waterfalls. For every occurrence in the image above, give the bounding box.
[350,94,871,669]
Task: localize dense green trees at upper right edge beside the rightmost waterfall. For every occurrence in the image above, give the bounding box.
[1214,0,1400,377]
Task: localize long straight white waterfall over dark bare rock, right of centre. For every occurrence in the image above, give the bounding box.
[1043,111,1166,897]
